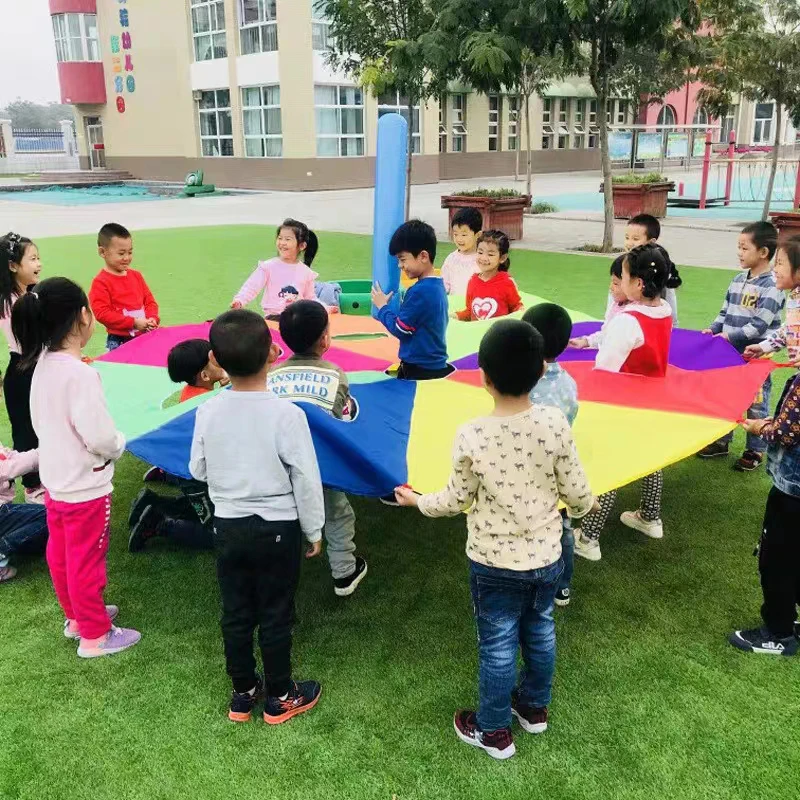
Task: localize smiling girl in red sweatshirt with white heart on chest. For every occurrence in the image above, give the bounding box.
[452,231,522,322]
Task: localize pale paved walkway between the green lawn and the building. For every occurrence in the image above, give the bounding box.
[0,172,758,269]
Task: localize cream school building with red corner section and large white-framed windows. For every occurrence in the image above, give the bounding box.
[49,0,800,190]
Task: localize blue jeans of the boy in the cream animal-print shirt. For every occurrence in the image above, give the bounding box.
[470,559,564,731]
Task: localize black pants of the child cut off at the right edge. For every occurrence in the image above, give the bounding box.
[758,486,800,639]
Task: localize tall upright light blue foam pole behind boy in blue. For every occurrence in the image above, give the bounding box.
[372,114,408,317]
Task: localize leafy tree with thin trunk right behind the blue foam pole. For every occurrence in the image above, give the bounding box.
[316,0,441,218]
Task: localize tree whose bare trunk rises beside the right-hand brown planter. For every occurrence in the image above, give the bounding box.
[563,0,699,253]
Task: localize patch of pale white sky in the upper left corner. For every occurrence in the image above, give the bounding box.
[0,0,60,108]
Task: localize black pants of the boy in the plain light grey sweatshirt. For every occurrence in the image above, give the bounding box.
[214,517,303,697]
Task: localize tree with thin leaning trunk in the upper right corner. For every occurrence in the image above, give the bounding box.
[699,0,800,219]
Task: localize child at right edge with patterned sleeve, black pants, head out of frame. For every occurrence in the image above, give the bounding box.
[728,368,800,656]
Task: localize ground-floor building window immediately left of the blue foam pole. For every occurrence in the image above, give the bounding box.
[314,86,364,156]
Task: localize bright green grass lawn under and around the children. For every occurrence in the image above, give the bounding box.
[0,226,800,800]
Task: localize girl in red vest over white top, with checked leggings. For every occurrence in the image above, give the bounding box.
[575,244,672,561]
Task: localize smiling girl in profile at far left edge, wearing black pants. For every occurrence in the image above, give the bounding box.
[0,233,44,505]
